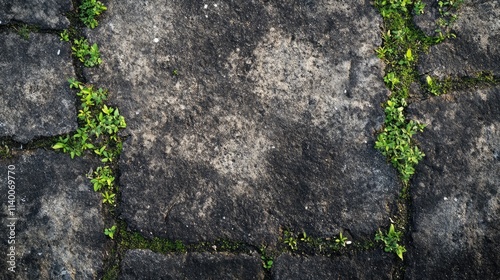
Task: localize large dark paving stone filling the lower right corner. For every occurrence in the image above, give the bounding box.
[406,87,500,279]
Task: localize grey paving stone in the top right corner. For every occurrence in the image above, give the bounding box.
[419,0,500,78]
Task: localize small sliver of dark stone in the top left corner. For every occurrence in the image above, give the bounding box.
[0,0,73,29]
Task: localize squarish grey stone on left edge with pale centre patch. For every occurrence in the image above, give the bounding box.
[0,33,77,143]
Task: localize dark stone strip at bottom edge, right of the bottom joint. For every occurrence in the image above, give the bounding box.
[272,251,396,280]
